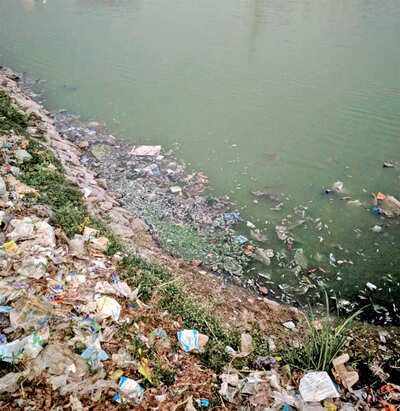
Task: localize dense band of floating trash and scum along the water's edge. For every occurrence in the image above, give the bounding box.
[5,67,398,326]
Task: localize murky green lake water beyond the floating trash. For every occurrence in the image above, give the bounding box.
[0,0,400,322]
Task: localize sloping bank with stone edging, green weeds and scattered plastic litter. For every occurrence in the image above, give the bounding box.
[0,68,400,410]
